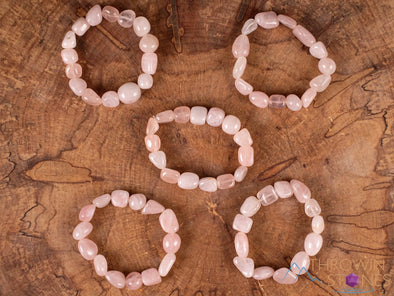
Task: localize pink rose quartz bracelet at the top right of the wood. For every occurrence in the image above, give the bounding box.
[232,11,336,111]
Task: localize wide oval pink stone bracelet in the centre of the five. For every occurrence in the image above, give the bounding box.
[145,106,254,192]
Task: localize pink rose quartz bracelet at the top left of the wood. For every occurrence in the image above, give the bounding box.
[61,5,159,107]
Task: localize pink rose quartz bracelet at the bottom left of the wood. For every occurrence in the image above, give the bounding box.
[73,190,181,290]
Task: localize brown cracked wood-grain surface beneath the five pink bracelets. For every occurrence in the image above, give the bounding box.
[0,0,394,296]
